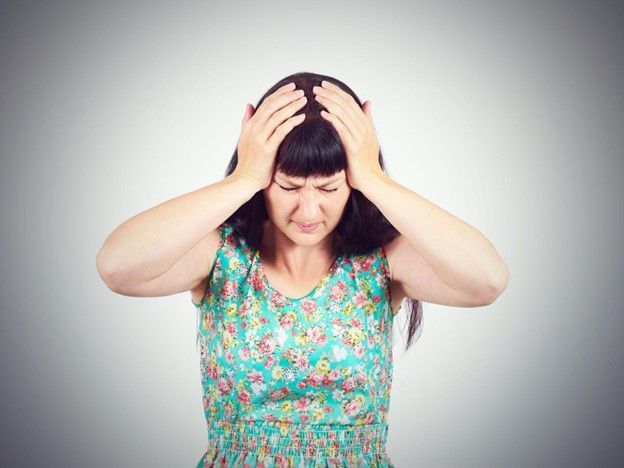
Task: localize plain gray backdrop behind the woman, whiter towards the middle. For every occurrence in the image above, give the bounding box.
[0,1,624,467]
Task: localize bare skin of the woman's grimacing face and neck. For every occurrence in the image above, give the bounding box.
[260,170,352,286]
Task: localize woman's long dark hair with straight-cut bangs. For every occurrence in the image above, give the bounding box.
[225,72,422,350]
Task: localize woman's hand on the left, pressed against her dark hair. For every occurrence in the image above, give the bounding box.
[233,83,307,190]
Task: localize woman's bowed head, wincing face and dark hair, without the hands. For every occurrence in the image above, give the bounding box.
[225,72,422,347]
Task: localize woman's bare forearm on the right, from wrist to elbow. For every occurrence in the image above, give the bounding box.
[362,174,508,293]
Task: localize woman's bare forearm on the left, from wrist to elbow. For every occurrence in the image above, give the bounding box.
[96,175,259,281]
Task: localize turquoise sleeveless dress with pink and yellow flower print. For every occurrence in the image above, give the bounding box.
[191,224,394,467]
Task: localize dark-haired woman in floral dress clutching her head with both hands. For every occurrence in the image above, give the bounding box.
[97,73,509,466]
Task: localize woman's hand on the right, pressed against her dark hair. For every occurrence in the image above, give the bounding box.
[312,81,385,190]
